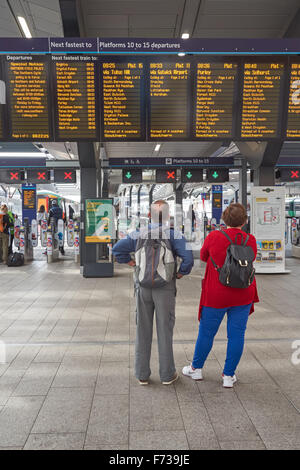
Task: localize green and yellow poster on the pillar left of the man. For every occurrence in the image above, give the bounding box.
[85,199,115,243]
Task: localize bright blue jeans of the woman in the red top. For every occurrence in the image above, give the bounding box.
[192,304,251,376]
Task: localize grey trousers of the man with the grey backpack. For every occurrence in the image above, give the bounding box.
[135,280,176,382]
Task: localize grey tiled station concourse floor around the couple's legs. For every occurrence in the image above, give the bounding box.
[0,255,300,450]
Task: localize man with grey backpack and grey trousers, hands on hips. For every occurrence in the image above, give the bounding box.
[113,201,194,385]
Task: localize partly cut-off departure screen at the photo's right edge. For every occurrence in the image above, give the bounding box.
[286,62,300,139]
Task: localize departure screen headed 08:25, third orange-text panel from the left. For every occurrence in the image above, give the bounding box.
[101,61,145,141]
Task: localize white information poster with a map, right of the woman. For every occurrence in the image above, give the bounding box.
[250,186,288,274]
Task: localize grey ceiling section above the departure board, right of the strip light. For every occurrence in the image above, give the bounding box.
[78,0,299,38]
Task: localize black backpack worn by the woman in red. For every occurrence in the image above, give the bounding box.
[210,232,255,289]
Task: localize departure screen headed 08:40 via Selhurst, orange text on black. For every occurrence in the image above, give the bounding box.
[241,62,284,139]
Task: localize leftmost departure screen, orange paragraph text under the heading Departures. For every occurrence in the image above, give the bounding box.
[5,55,51,141]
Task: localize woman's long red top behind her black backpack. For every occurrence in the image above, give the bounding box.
[198,228,259,320]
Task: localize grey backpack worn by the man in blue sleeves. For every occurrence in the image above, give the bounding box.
[135,230,176,288]
